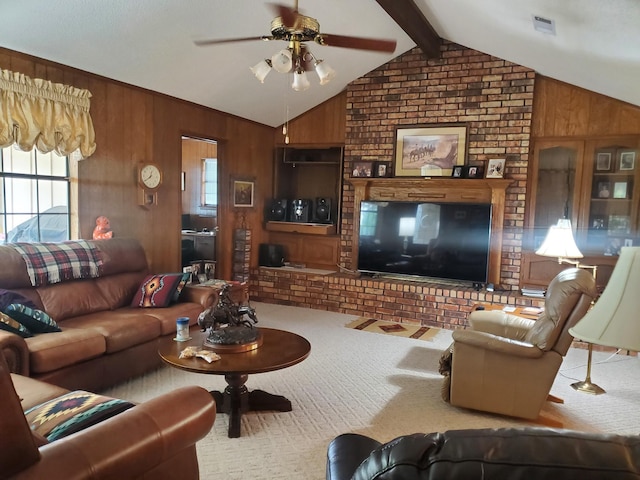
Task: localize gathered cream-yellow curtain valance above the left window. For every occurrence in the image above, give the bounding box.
[0,69,96,158]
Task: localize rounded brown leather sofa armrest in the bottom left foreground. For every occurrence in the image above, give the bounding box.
[15,386,216,479]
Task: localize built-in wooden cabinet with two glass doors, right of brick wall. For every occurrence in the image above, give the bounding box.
[521,135,640,287]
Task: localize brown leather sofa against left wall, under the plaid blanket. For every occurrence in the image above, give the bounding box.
[0,238,217,391]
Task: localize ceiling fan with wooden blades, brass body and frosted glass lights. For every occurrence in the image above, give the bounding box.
[194,0,396,91]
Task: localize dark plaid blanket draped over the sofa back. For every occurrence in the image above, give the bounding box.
[8,240,102,287]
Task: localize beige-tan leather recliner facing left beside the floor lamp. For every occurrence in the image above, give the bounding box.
[443,268,597,420]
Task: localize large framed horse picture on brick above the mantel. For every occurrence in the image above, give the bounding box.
[394,125,467,177]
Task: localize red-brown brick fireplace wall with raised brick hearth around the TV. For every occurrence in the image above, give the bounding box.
[251,42,543,328]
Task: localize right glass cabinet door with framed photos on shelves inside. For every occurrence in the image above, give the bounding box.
[582,138,640,256]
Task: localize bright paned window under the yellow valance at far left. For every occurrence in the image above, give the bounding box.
[0,146,70,243]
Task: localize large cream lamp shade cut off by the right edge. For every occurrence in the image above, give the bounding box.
[569,247,640,351]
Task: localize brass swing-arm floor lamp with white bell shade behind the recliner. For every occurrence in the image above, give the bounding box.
[536,218,605,395]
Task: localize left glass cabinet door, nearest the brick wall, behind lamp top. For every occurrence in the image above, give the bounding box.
[523,140,584,251]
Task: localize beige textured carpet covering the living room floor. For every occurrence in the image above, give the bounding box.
[102,303,640,480]
